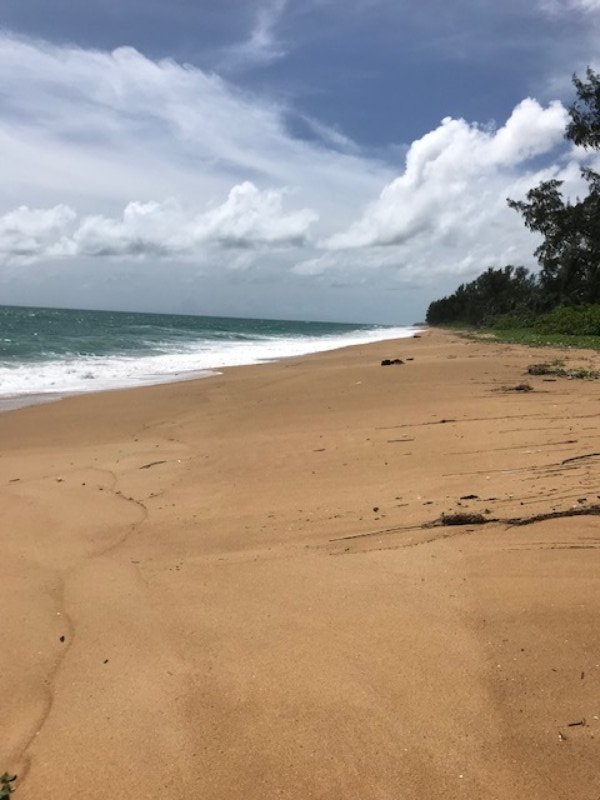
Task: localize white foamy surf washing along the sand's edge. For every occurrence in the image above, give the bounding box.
[0,328,417,409]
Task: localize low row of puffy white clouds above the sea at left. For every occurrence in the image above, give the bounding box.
[0,181,317,263]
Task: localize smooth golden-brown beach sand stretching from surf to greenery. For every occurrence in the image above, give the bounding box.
[0,332,600,800]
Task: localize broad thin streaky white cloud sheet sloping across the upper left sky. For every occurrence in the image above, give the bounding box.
[0,35,391,221]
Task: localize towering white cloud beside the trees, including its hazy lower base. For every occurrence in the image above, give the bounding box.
[314,99,566,282]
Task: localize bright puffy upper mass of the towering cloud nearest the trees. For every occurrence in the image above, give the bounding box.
[324,100,566,249]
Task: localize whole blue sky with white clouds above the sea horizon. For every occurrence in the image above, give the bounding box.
[0,0,600,324]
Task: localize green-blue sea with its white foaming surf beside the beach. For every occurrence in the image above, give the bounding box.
[0,306,415,409]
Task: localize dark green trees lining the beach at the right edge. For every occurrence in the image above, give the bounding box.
[426,67,600,334]
